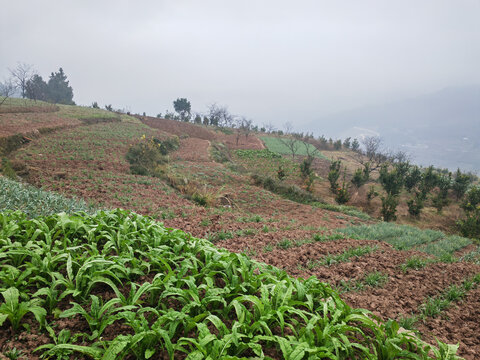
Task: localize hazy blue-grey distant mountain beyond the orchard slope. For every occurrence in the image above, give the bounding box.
[309,85,480,173]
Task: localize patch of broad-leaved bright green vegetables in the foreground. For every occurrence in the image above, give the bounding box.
[0,210,455,359]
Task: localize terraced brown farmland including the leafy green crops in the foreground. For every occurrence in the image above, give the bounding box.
[0,102,480,359]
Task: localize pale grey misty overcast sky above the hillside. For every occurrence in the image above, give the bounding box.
[0,0,480,128]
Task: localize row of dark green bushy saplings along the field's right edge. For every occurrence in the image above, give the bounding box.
[328,160,480,237]
